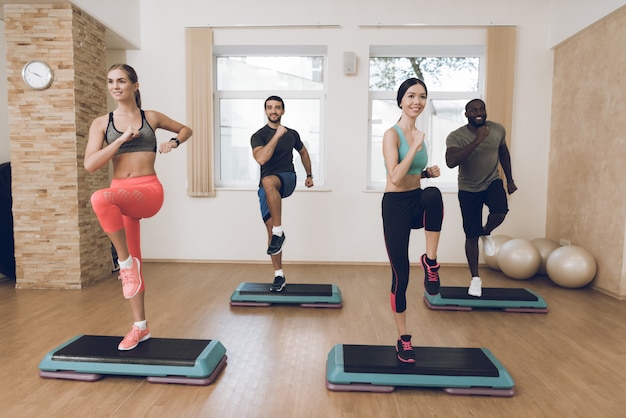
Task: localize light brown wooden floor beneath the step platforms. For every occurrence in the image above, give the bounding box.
[0,263,626,418]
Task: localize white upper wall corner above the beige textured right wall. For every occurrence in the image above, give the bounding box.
[549,0,626,47]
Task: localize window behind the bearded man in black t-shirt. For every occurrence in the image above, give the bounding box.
[214,46,325,188]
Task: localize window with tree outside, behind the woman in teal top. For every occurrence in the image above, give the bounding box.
[367,46,484,191]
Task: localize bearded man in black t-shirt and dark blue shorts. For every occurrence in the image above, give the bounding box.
[250,96,313,292]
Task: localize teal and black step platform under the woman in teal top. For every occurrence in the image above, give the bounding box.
[326,344,514,397]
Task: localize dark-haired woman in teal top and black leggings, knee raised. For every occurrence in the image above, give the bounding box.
[382,78,443,363]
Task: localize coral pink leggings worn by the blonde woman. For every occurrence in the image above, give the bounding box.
[91,175,163,270]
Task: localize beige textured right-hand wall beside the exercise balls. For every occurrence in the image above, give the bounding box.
[546,6,626,298]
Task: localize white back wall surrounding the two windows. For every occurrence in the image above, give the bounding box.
[127,0,552,263]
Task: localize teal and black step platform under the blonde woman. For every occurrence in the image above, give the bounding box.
[39,335,227,386]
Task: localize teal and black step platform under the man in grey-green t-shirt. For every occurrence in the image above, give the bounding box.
[424,286,548,313]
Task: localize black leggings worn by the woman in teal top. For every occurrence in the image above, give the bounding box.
[382,187,443,313]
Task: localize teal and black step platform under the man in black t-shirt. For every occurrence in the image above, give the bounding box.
[230,282,342,308]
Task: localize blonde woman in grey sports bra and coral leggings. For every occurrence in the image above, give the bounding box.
[84,64,191,350]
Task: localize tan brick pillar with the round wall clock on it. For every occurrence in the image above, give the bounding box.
[4,3,111,289]
